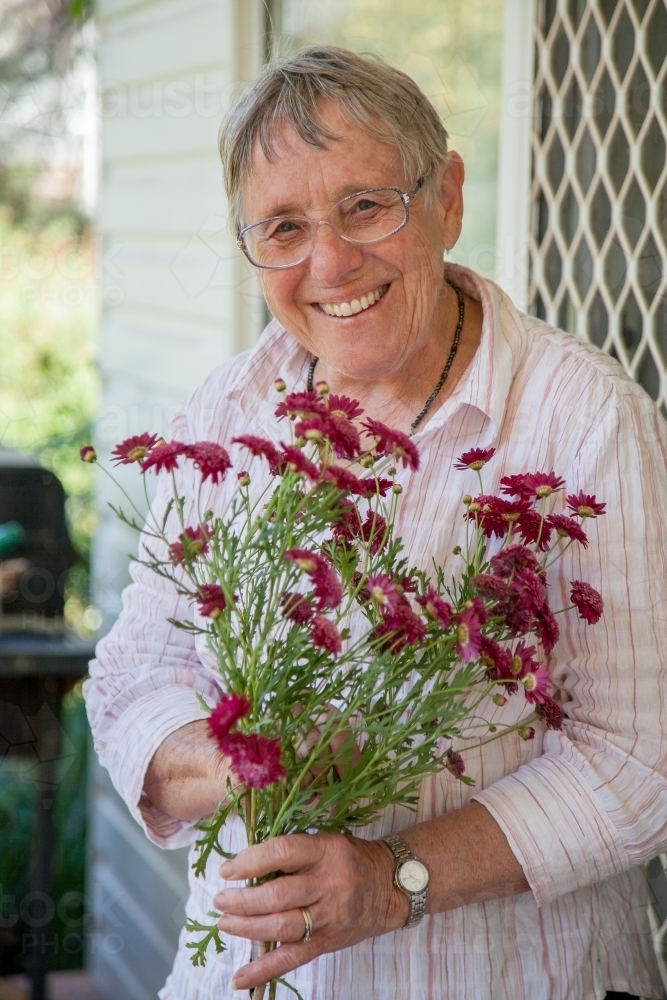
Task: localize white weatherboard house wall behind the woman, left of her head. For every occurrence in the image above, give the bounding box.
[88,0,263,1000]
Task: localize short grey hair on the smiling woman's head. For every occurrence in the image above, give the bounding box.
[220,45,447,230]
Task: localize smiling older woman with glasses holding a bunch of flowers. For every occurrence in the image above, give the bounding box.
[86,47,667,1000]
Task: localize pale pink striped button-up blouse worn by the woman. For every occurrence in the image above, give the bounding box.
[85,264,667,1000]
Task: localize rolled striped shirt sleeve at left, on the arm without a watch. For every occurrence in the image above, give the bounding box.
[84,415,220,847]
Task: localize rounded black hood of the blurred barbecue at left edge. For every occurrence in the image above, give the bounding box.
[0,448,78,634]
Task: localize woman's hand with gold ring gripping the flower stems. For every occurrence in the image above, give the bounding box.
[214,833,410,990]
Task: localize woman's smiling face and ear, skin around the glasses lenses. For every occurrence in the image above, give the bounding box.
[242,105,463,380]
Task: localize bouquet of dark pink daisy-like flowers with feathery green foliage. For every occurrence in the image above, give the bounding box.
[82,379,604,996]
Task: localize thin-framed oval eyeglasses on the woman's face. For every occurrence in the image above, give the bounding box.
[236,174,426,268]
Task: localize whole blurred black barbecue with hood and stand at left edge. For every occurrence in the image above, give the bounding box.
[0,448,94,1000]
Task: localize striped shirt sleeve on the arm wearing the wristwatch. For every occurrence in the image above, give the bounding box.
[474,383,667,905]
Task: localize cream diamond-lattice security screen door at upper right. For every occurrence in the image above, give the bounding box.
[529,0,667,417]
